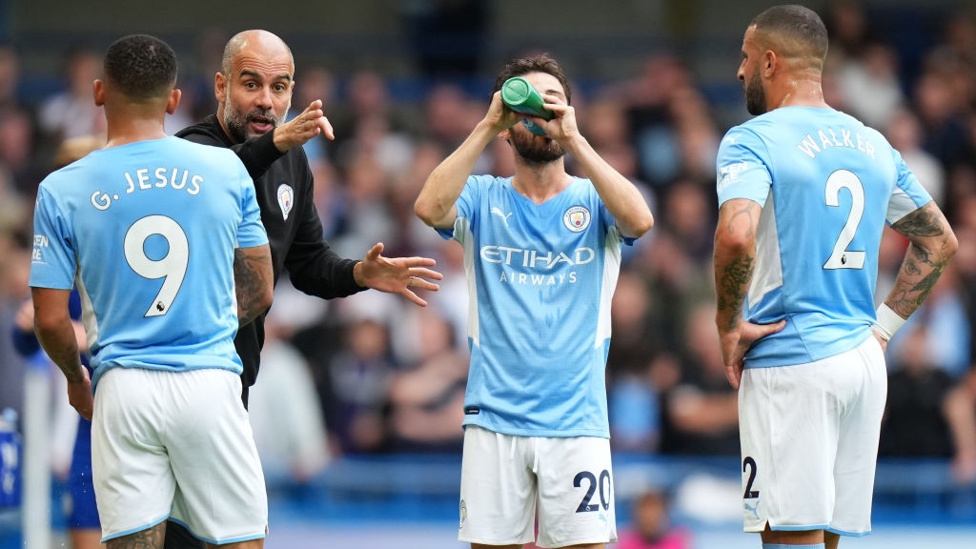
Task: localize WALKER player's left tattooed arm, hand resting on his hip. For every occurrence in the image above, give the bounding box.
[714,198,786,389]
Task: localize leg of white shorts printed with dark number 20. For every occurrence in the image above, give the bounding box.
[534,437,617,547]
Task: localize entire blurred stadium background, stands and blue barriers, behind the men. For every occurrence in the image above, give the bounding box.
[0,0,976,549]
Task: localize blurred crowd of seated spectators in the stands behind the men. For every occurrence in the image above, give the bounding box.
[0,2,976,492]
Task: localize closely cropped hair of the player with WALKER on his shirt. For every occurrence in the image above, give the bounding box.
[750,5,828,70]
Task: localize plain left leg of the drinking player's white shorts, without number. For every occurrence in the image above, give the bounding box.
[458,425,537,545]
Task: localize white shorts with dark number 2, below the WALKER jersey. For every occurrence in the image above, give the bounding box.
[739,336,888,536]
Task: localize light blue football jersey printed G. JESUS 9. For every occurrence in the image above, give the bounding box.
[30,137,268,384]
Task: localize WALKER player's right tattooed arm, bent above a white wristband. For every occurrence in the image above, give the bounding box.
[884,202,959,334]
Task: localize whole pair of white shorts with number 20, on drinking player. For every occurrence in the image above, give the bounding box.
[458,425,617,547]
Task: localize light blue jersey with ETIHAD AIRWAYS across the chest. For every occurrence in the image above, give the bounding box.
[438,175,633,438]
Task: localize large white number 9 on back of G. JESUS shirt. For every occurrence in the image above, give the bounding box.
[125,215,190,318]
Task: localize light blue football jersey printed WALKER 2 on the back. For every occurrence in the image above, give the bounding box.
[717,107,932,368]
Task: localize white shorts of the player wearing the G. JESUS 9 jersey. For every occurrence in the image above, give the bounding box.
[92,368,268,544]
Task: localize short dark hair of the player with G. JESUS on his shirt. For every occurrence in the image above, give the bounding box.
[104,34,177,99]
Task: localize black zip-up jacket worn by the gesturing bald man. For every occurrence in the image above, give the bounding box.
[176,114,366,407]
